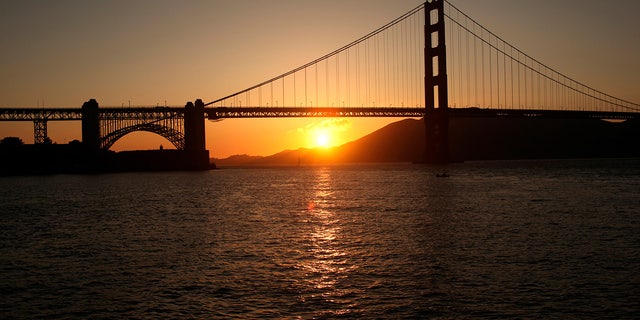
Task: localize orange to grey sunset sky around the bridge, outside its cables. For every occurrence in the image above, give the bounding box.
[0,0,640,157]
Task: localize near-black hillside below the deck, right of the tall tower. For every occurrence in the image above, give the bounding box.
[449,118,640,160]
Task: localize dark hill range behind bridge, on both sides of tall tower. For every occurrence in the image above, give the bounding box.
[214,118,640,166]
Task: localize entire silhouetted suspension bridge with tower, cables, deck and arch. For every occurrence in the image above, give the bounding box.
[0,0,640,162]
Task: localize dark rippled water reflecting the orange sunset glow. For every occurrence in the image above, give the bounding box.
[0,159,640,319]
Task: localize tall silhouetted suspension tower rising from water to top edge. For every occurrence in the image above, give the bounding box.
[424,0,449,164]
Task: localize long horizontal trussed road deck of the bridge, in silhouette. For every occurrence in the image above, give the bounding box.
[0,107,640,121]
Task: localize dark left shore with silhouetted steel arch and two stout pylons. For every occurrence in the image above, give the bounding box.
[0,99,212,175]
